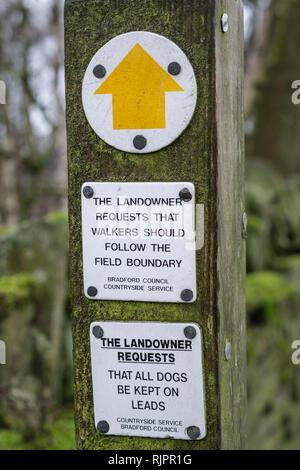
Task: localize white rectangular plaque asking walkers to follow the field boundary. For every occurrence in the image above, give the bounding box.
[82,182,197,302]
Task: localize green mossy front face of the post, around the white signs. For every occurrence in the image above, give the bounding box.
[65,0,245,450]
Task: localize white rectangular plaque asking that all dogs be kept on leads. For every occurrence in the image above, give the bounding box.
[90,322,206,440]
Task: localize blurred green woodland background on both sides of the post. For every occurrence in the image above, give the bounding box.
[0,0,300,449]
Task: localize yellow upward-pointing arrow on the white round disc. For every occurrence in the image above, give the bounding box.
[95,44,183,130]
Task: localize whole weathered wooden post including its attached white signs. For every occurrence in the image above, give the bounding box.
[65,0,246,450]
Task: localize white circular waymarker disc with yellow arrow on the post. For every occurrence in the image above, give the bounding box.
[82,31,197,153]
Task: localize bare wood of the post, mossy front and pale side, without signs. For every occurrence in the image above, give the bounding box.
[65,0,247,450]
